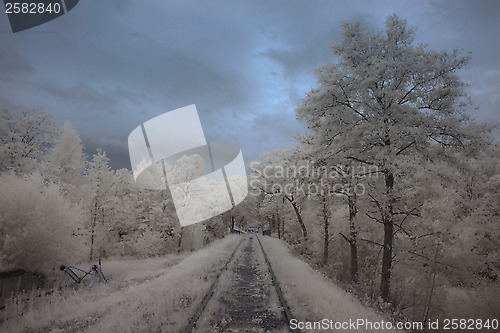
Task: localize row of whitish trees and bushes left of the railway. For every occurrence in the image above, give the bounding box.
[0,109,241,276]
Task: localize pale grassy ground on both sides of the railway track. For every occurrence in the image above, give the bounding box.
[0,235,414,332]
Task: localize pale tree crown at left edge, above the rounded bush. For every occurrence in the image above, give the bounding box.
[0,109,58,174]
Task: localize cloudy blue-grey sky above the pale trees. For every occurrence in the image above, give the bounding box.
[0,0,500,168]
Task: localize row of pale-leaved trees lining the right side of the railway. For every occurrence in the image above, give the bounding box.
[251,15,500,320]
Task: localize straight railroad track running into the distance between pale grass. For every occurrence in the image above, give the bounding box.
[184,235,297,333]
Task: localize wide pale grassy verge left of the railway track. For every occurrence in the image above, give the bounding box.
[0,235,241,332]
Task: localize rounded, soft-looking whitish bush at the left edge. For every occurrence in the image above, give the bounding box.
[0,174,83,275]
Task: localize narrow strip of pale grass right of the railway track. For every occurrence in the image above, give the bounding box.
[260,237,408,332]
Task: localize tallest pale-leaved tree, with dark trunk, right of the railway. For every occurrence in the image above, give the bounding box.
[297,15,487,300]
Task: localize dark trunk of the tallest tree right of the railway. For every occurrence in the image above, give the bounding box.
[380,171,394,302]
